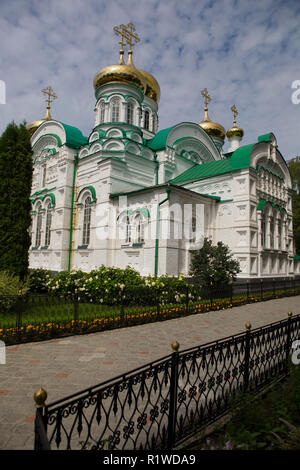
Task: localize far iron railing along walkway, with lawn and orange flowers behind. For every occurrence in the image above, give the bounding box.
[0,278,300,344]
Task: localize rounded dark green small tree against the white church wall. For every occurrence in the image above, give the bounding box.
[190,238,241,288]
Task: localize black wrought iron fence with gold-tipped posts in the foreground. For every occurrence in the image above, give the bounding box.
[35,314,300,450]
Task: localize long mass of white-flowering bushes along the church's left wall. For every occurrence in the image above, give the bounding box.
[30,265,192,305]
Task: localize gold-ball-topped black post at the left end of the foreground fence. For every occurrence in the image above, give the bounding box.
[34,388,51,450]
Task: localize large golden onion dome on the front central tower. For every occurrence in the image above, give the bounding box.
[94,51,147,93]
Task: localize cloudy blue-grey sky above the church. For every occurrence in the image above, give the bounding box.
[0,0,300,159]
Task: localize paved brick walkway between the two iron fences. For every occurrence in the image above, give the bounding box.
[0,296,300,450]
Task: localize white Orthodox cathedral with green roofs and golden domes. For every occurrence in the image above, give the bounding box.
[28,25,300,279]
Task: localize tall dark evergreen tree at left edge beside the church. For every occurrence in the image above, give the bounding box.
[0,122,32,279]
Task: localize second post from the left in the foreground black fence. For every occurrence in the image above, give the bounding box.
[168,341,179,450]
